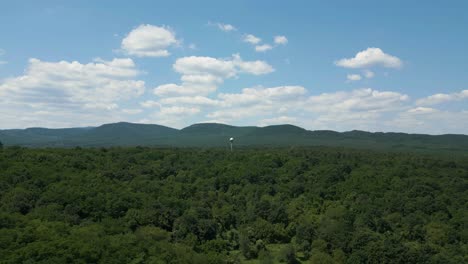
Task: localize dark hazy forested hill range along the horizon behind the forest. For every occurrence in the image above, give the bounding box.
[0,122,468,153]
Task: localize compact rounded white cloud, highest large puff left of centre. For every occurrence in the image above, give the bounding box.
[121,24,178,57]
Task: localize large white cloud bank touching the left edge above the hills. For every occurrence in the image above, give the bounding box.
[0,59,145,127]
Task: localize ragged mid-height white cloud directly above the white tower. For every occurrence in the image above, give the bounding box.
[154,54,274,97]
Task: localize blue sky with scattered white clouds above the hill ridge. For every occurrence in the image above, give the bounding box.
[0,0,468,134]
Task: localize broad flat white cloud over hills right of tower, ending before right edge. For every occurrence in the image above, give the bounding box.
[201,86,409,131]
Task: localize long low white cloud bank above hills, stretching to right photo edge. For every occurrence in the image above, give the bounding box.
[201,86,468,134]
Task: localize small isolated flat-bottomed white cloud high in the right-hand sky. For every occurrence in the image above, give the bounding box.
[335,48,403,69]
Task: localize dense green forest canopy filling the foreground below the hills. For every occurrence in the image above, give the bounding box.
[0,147,468,264]
